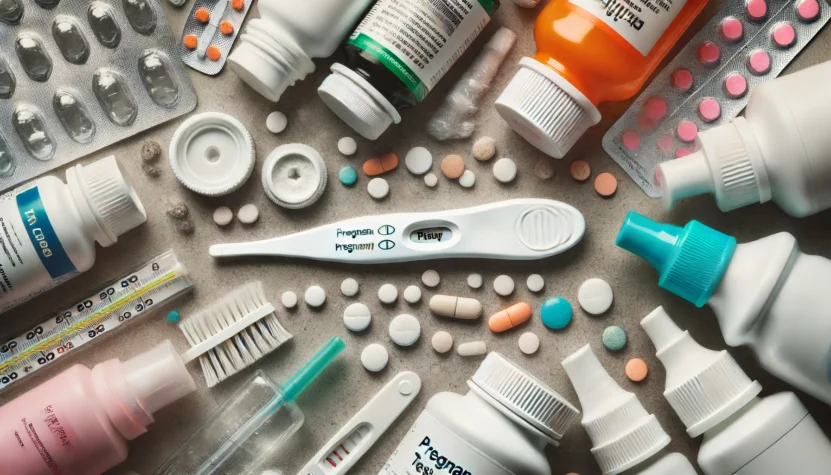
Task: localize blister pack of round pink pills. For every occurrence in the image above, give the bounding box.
[603,0,831,197]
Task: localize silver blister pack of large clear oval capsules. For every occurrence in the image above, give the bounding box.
[0,0,196,189]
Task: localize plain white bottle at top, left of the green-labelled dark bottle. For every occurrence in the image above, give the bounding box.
[228,0,372,102]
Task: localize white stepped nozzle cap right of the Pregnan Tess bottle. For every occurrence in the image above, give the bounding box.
[562,345,670,475]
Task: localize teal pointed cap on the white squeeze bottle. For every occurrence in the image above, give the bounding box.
[615,211,736,307]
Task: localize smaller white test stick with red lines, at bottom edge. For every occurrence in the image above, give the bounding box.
[297,371,421,475]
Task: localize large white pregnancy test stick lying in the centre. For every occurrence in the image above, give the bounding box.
[210,198,586,264]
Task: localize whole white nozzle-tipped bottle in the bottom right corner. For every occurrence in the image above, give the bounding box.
[641,307,831,475]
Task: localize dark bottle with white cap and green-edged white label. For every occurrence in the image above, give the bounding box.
[318,0,499,140]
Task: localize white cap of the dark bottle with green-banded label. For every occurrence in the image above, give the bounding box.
[317,63,401,140]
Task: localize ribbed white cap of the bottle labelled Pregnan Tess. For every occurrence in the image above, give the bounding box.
[468,353,580,444]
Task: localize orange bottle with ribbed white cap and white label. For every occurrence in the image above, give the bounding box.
[496,0,707,158]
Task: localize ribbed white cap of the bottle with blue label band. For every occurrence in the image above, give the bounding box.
[66,156,147,247]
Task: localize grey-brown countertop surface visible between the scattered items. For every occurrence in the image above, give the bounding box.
[0,0,831,475]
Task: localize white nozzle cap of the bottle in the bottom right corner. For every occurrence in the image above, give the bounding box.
[641,307,762,437]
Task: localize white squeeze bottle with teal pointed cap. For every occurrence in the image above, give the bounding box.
[617,211,831,404]
